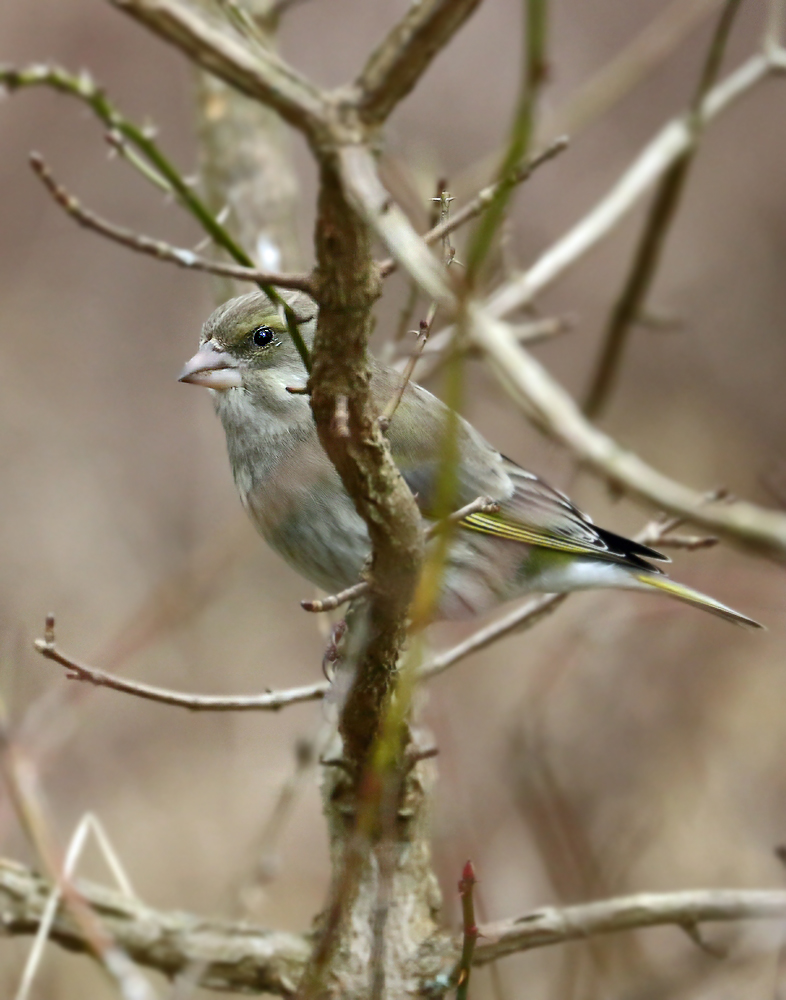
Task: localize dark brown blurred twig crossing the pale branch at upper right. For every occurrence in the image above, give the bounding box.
[584,0,740,417]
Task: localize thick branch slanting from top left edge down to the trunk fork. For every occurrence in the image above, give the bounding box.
[110,0,326,138]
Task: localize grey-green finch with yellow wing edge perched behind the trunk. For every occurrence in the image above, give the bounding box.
[179,291,762,628]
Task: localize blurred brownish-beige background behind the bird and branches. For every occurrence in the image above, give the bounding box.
[0,0,786,1000]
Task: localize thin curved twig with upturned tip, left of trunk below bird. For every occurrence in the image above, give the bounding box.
[34,615,330,712]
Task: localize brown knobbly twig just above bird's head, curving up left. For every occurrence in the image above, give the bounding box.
[30,153,313,292]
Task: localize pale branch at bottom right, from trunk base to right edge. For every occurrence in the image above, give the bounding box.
[468,889,786,965]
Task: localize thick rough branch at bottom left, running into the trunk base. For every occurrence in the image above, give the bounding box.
[0,860,310,997]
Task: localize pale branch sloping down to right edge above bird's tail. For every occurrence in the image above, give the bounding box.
[472,310,786,560]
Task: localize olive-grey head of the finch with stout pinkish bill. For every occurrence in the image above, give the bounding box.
[179,292,317,406]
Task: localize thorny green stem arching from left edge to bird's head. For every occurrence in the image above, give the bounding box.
[0,65,311,371]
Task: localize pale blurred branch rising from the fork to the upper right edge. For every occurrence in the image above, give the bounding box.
[488,48,786,318]
